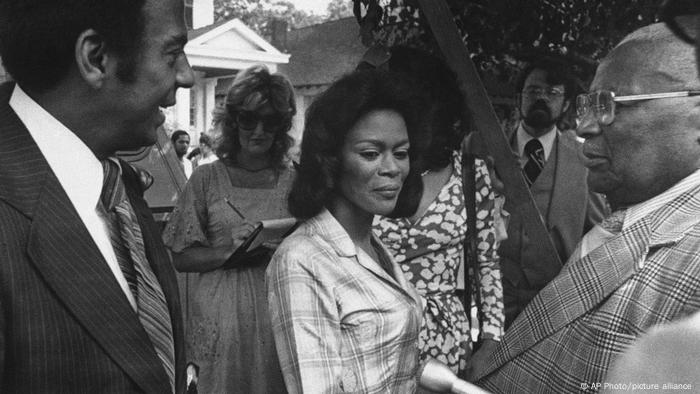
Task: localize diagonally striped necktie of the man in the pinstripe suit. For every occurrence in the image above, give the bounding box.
[98,160,175,391]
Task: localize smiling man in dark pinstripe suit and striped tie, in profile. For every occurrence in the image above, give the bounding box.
[0,0,193,393]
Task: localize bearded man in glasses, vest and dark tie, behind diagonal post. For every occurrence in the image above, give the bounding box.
[499,59,606,329]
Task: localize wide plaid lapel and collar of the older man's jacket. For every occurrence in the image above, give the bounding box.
[476,186,700,379]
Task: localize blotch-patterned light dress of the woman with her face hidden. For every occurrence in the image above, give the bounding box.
[374,152,505,373]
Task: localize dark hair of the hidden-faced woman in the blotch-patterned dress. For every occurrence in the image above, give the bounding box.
[389,46,469,170]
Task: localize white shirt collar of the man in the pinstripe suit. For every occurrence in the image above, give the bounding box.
[9,85,103,211]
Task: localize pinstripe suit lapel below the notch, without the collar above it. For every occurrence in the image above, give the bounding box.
[27,178,169,391]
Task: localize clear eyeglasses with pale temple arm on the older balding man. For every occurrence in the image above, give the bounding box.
[576,90,700,125]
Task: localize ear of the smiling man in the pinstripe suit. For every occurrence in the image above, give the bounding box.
[75,29,110,88]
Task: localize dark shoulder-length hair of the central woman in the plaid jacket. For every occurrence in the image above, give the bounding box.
[289,70,422,219]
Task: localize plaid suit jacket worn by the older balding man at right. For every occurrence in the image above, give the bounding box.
[476,186,700,393]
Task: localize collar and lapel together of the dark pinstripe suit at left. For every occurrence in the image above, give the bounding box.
[0,84,170,392]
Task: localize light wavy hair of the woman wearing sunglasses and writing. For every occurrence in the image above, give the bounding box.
[214,65,297,166]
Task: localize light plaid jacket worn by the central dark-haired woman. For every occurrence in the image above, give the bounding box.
[267,210,422,394]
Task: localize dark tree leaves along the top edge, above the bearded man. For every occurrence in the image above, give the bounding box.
[353,0,659,83]
